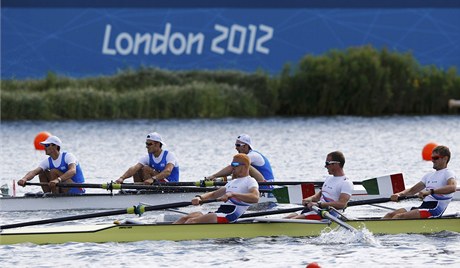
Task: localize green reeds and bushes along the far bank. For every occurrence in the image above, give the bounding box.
[1,46,460,120]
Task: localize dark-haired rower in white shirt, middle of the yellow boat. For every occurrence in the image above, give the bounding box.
[286,151,353,220]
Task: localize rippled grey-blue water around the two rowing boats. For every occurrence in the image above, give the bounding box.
[0,116,460,267]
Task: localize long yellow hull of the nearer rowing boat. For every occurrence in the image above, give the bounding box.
[0,216,460,245]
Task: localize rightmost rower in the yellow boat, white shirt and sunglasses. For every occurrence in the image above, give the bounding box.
[383,145,457,219]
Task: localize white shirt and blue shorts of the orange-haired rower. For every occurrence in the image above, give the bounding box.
[215,176,259,223]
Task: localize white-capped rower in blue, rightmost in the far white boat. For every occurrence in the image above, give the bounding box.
[206,134,275,189]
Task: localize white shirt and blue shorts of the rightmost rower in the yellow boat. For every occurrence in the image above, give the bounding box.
[406,168,457,218]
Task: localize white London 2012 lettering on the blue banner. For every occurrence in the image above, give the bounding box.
[102,23,274,56]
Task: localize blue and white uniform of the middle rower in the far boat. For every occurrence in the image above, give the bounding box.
[139,150,179,182]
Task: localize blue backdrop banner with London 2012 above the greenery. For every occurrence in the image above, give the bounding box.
[1,0,460,79]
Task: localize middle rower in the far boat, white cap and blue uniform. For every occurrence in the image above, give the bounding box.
[116,132,179,185]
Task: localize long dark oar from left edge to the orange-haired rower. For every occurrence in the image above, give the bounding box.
[0,199,218,230]
